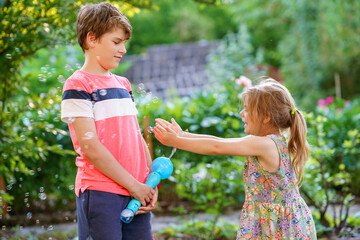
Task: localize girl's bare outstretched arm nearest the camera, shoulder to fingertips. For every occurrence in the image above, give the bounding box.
[153,119,280,172]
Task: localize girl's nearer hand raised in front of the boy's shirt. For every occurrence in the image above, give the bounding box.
[153,119,182,147]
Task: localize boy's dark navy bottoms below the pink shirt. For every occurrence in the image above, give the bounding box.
[76,190,153,240]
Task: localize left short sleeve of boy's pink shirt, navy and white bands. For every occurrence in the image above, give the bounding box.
[61,79,94,123]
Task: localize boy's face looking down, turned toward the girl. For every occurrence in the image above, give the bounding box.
[92,28,126,70]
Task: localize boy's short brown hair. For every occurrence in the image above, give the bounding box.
[76,2,132,52]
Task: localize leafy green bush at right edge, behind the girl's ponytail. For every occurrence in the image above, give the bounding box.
[302,98,360,237]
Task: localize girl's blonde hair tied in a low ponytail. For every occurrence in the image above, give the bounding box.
[242,78,310,185]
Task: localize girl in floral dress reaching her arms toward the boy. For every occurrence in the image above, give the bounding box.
[153,79,316,239]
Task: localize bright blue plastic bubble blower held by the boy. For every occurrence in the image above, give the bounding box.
[120,148,176,223]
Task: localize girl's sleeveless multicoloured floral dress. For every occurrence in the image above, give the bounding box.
[236,135,317,240]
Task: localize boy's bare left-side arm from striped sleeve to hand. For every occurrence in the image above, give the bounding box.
[72,117,155,206]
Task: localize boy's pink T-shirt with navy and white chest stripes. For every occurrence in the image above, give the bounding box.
[61,70,150,196]
